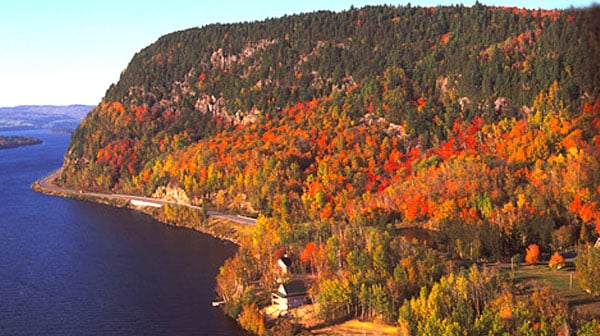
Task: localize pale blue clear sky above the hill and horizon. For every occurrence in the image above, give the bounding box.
[0,0,593,107]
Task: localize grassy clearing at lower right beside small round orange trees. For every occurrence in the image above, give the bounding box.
[509,261,600,318]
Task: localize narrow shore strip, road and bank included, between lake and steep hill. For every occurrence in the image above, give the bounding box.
[31,167,255,246]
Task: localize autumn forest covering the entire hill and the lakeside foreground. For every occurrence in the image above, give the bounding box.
[60,4,600,335]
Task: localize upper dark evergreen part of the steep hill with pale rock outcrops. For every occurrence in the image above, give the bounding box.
[59,5,599,194]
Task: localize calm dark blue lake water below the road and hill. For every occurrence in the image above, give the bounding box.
[0,131,242,335]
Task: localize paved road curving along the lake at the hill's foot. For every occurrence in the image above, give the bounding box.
[38,168,256,225]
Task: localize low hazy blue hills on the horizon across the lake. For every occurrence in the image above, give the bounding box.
[0,105,94,130]
